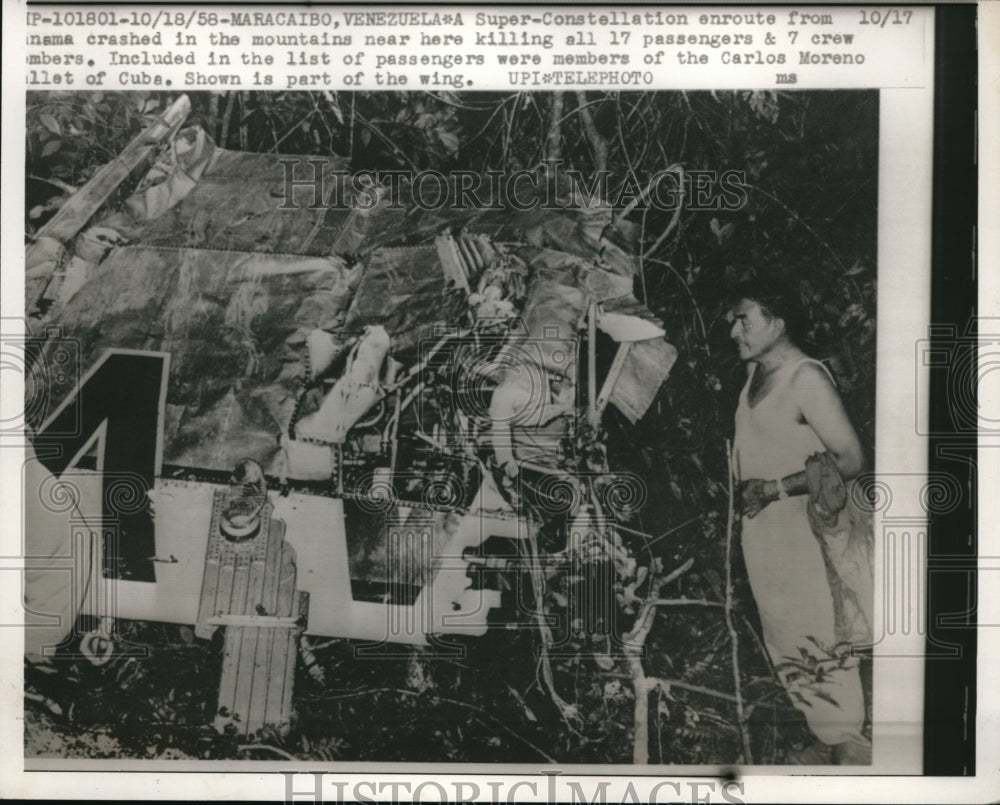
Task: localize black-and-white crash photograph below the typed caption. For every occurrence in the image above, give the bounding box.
[19,86,879,766]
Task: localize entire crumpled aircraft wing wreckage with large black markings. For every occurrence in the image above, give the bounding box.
[24,97,676,733]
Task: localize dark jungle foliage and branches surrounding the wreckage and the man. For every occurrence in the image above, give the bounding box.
[26,91,878,764]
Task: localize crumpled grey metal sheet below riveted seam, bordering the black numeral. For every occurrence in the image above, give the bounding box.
[41,246,352,471]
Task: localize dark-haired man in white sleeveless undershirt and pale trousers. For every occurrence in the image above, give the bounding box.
[729,288,871,764]
